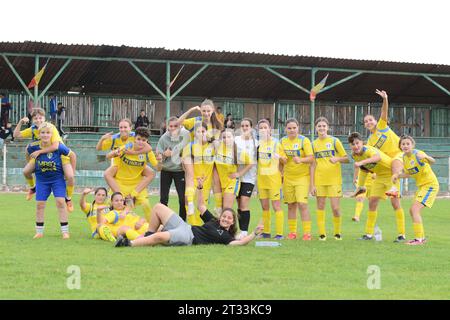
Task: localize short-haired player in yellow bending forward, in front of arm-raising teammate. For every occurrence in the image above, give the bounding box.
[348,132,405,242]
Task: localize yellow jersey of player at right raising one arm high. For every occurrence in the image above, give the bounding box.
[367,119,401,158]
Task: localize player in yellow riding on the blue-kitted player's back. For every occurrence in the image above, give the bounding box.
[14,108,77,212]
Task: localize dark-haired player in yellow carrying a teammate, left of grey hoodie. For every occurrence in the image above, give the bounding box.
[104,127,162,220]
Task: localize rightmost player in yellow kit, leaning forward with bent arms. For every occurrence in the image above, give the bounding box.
[392,136,439,245]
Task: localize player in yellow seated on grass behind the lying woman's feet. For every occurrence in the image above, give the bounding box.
[97,192,148,241]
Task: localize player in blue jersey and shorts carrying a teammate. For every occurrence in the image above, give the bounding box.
[27,122,75,239]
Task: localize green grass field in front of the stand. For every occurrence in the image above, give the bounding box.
[0,194,450,300]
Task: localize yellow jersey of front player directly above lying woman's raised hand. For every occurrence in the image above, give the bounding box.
[182,141,215,183]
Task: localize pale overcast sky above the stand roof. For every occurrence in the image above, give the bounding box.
[0,0,450,65]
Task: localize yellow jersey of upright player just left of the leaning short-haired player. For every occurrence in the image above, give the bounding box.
[313,136,347,186]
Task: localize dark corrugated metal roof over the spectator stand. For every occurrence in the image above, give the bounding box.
[0,41,450,104]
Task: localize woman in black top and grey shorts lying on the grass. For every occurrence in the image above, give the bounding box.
[116,178,264,247]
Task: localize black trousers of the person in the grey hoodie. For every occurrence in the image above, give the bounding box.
[159,170,186,221]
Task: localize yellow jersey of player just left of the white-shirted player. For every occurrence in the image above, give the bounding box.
[215,142,251,182]
